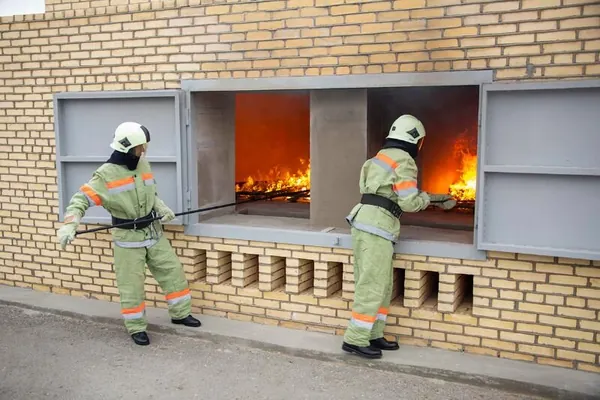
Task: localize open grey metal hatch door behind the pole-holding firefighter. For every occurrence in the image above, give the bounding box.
[54,90,185,225]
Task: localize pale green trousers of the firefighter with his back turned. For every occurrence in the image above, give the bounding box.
[344,228,394,347]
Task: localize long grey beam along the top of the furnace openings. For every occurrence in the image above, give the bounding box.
[181,70,494,92]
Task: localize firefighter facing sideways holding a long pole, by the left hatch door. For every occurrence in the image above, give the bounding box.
[58,122,201,345]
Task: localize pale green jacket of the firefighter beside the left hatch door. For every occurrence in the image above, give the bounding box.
[65,159,169,248]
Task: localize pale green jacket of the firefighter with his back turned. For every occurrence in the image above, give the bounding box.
[346,148,427,242]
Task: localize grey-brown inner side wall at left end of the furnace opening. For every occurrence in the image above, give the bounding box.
[191,92,235,220]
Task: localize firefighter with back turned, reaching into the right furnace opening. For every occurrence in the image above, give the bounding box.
[342,115,456,358]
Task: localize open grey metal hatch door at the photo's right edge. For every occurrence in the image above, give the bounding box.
[476,80,600,260]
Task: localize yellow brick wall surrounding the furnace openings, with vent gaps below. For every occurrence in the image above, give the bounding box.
[0,0,600,372]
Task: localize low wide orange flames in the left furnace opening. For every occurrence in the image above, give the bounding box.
[235,159,310,193]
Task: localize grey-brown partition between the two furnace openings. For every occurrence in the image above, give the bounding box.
[310,89,367,227]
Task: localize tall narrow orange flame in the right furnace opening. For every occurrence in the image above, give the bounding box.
[448,132,477,200]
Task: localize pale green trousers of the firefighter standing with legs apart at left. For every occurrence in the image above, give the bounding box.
[114,236,191,335]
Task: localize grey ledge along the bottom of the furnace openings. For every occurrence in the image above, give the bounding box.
[184,221,487,261]
